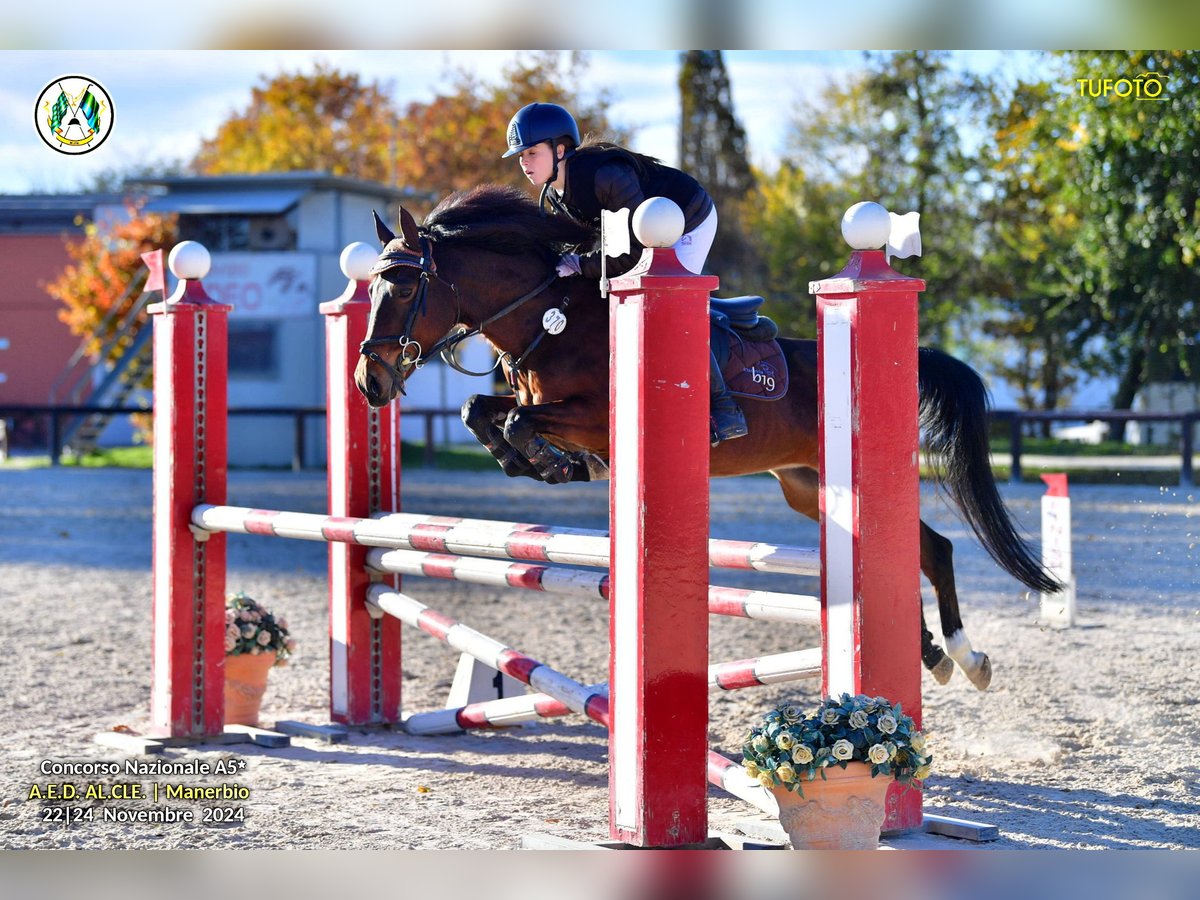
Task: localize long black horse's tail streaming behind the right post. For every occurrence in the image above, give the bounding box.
[918,347,1062,593]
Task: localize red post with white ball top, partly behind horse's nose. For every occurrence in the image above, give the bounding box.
[320,241,401,725]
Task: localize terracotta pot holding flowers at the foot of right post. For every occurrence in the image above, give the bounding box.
[772,762,892,850]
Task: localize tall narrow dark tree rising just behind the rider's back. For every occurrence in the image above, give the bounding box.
[679,50,755,287]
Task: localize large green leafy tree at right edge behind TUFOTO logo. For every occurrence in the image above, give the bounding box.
[1048,50,1200,409]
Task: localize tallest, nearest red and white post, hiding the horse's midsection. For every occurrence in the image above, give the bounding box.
[608,197,718,847]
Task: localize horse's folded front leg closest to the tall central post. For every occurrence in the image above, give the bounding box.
[504,400,608,485]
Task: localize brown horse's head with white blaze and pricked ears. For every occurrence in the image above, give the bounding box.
[354,208,457,407]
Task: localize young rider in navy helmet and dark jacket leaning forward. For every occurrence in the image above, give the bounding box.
[502,103,748,446]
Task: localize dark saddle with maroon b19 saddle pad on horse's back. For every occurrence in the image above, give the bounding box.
[708,295,787,400]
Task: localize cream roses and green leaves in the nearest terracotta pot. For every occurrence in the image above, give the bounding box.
[742,694,934,797]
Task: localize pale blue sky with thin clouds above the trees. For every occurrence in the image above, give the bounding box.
[0,50,1031,193]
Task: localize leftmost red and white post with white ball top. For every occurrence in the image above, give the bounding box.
[150,241,233,737]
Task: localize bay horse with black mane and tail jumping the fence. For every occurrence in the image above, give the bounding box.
[354,185,1060,690]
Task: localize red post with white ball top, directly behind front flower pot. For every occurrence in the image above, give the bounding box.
[809,203,925,830]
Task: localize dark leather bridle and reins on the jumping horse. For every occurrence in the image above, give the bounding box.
[359,235,565,394]
